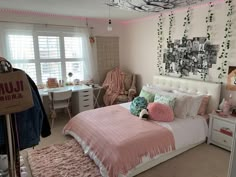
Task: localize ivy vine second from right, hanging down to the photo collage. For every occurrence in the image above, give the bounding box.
[206,2,215,41]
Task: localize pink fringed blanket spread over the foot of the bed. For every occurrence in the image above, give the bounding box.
[64,105,175,177]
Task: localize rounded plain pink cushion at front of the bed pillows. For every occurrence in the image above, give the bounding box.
[147,102,174,122]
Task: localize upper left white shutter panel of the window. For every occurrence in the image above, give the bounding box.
[8,35,35,60]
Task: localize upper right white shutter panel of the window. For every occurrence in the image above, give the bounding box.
[64,37,83,58]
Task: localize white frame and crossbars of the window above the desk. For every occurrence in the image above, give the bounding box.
[4,29,86,84]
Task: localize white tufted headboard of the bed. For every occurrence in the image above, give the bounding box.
[153,75,221,113]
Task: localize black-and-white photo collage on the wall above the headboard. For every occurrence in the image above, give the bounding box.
[163,37,220,77]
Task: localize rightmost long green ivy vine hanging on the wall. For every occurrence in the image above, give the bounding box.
[217,0,233,80]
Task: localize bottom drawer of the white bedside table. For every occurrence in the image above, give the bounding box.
[212,131,233,148]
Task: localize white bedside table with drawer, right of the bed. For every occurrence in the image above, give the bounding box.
[207,114,236,151]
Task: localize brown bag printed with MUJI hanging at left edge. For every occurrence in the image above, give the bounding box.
[0,61,34,115]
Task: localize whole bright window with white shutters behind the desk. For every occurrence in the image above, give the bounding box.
[7,32,84,84]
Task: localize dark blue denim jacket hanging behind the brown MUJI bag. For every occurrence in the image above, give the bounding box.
[0,69,51,154]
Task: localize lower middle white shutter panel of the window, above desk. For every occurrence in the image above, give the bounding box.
[41,62,62,83]
